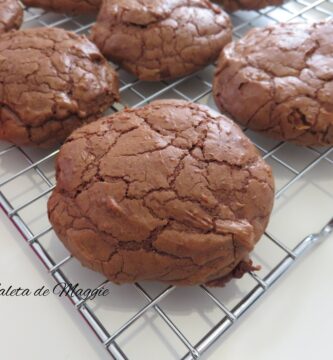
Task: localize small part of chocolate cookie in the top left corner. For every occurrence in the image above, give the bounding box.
[0,0,23,34]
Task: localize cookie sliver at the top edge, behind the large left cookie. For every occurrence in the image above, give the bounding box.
[22,0,102,14]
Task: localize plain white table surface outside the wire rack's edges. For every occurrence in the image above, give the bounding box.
[0,207,333,360]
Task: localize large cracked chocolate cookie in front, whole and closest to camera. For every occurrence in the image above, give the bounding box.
[48,100,274,285]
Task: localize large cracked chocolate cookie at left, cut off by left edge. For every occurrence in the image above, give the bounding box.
[0,28,118,147]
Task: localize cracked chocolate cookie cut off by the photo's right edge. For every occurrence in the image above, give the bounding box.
[214,20,333,146]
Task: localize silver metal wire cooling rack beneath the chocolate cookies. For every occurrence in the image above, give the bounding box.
[0,0,333,360]
